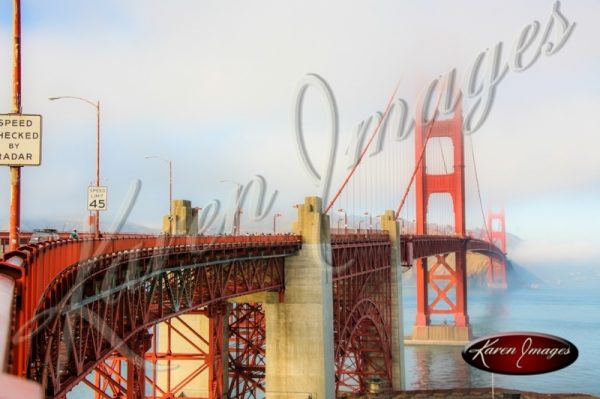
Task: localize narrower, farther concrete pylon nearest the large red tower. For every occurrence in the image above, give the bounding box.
[381,211,405,391]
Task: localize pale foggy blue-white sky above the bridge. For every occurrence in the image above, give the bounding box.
[0,0,600,263]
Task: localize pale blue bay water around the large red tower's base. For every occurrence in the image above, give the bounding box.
[403,284,600,396]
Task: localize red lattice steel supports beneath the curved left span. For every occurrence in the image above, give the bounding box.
[75,302,265,399]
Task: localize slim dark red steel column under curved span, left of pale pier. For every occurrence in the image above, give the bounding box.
[127,331,152,399]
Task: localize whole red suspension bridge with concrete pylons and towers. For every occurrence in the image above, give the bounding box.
[0,107,506,398]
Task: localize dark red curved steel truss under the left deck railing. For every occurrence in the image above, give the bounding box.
[17,244,299,396]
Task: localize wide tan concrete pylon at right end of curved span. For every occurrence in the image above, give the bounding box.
[264,197,335,399]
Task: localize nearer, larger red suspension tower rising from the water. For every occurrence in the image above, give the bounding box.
[413,103,471,341]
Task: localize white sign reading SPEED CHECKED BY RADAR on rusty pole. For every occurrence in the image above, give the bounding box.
[0,114,42,166]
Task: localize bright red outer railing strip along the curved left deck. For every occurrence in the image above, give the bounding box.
[2,235,300,377]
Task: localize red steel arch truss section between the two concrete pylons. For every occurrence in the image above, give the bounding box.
[331,234,392,394]
